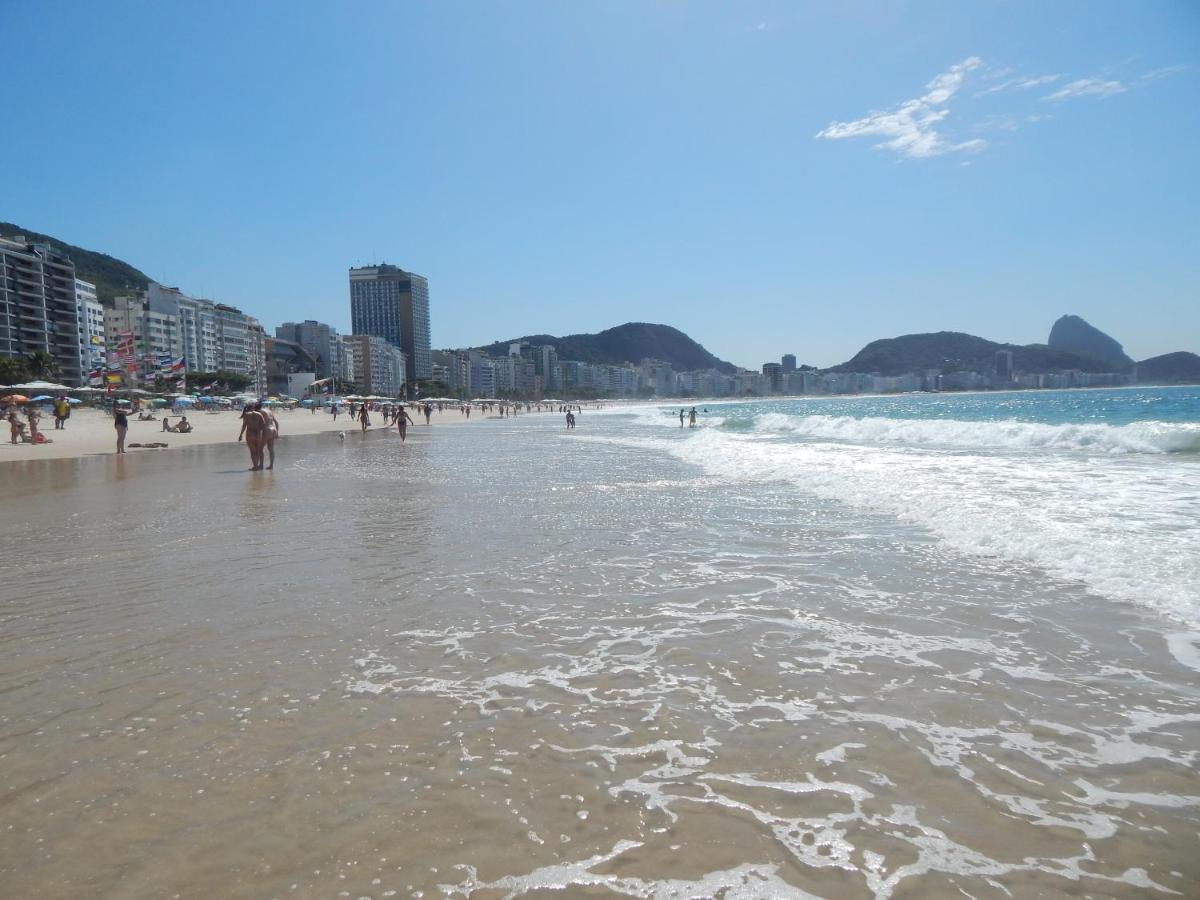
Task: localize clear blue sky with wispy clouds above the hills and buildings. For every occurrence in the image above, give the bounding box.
[0,0,1200,368]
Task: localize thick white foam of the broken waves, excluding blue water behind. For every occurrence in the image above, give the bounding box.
[628,422,1200,626]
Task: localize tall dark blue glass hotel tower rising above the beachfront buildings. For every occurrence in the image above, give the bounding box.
[350,263,433,384]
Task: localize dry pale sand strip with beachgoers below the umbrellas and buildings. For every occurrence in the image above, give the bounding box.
[0,407,486,463]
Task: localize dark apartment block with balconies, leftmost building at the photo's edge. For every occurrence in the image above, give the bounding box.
[0,236,84,385]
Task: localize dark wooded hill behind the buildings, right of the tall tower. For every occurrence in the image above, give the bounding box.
[475,322,737,373]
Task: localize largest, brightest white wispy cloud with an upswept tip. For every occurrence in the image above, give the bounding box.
[816,56,986,160]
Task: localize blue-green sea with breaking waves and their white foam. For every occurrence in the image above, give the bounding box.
[600,388,1200,626]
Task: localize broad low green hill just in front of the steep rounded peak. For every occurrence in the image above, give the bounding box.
[826,331,1124,376]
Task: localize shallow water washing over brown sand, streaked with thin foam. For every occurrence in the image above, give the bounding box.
[0,413,1200,898]
